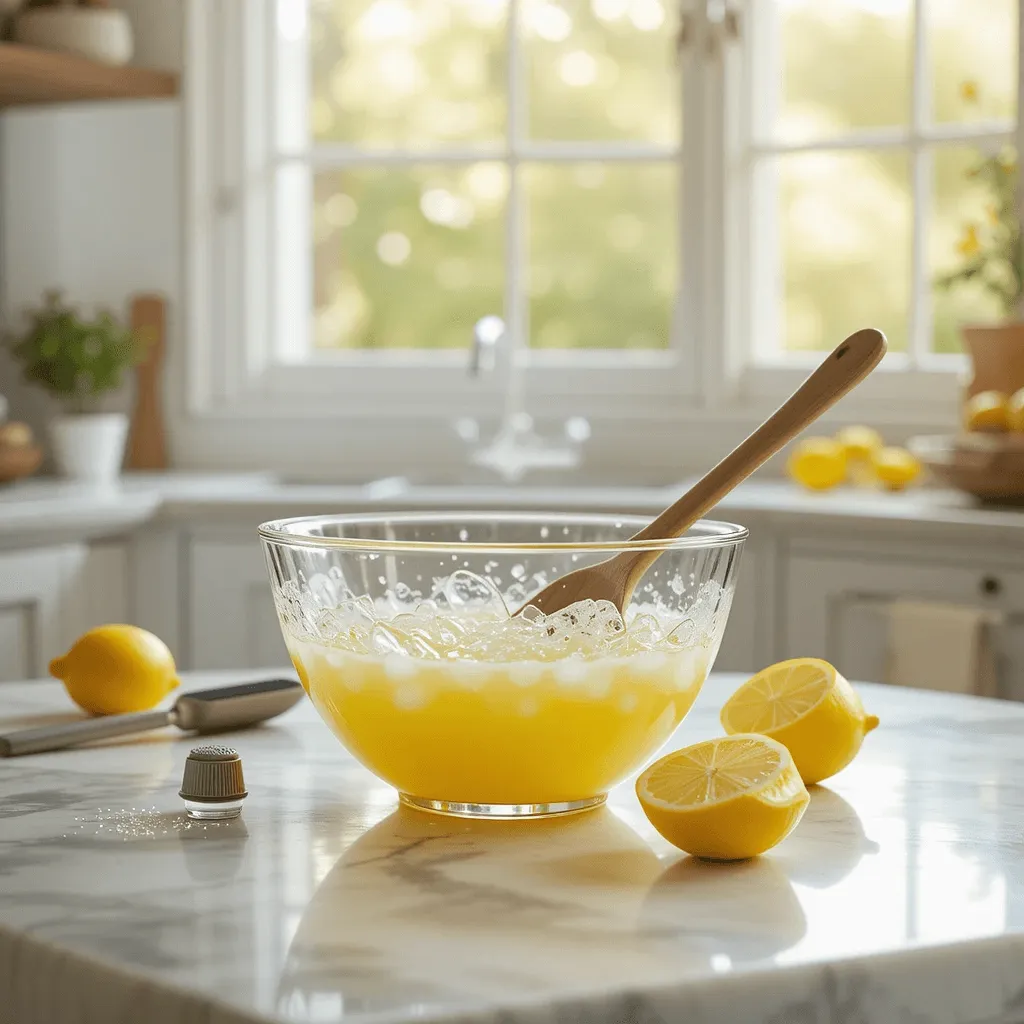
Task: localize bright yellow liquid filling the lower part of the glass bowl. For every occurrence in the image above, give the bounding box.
[289,638,708,804]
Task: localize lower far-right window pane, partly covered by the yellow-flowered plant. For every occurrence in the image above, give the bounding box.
[929,145,1016,352]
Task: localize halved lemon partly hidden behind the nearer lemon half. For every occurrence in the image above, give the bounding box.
[721,657,879,785]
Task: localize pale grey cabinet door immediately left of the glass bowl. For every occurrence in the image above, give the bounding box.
[188,539,290,669]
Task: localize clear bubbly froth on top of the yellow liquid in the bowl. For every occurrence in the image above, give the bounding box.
[299,565,717,663]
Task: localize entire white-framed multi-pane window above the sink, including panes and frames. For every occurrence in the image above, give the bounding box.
[186,0,1020,471]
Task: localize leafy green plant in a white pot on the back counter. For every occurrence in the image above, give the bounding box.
[8,292,142,483]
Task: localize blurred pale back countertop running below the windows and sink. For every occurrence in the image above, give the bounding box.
[0,473,1024,547]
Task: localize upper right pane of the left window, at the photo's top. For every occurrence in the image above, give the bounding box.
[520,0,680,142]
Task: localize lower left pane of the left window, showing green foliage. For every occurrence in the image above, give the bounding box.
[313,163,508,349]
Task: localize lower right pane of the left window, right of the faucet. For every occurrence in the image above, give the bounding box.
[524,164,679,349]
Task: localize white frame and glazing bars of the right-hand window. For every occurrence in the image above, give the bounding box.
[720,0,1024,425]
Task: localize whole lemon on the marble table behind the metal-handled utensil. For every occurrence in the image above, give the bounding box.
[50,625,178,715]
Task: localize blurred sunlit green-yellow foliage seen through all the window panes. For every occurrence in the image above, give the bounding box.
[310,0,1017,351]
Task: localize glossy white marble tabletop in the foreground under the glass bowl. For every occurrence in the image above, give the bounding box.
[0,674,1024,1024]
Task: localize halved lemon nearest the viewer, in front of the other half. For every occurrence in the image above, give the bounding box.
[637,734,810,860]
